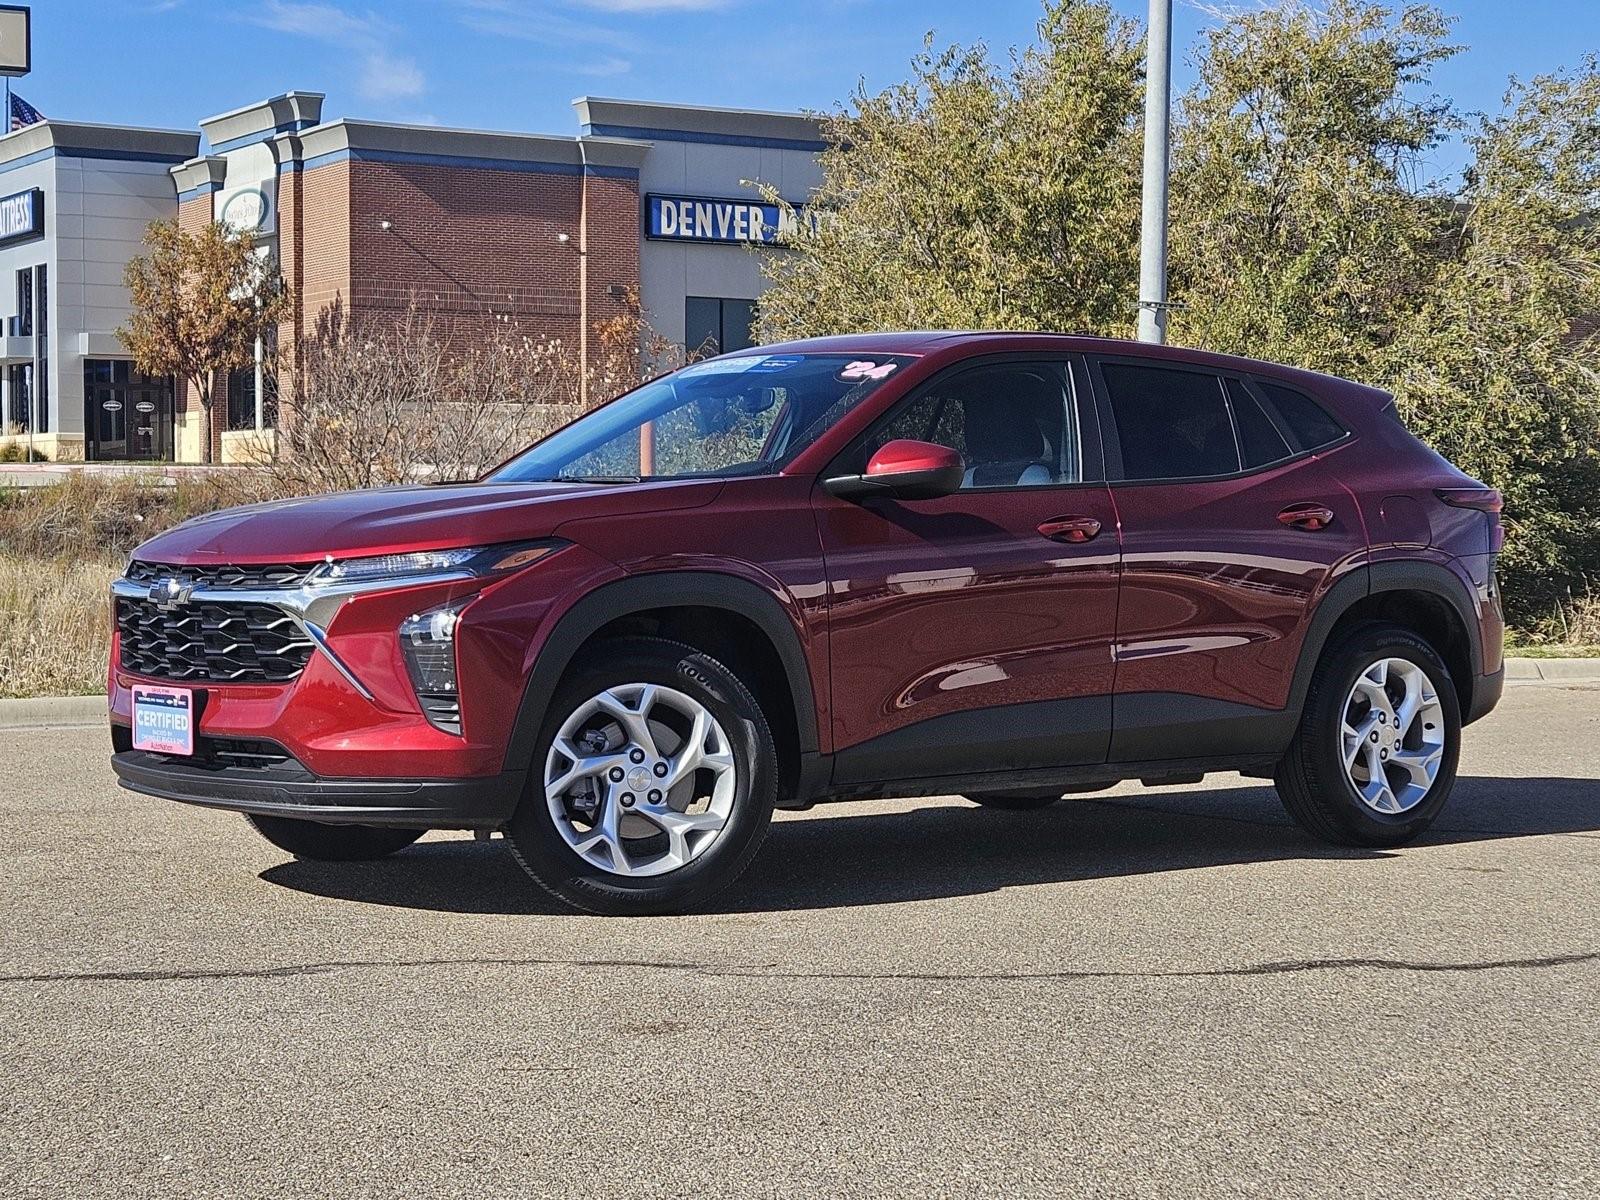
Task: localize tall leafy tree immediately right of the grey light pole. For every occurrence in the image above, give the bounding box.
[1171,0,1456,382]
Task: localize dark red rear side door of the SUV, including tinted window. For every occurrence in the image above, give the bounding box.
[1090,357,1366,762]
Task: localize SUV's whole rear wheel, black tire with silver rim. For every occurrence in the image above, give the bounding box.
[1274,622,1461,846]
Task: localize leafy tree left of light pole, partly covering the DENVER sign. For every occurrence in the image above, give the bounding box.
[757,0,1144,341]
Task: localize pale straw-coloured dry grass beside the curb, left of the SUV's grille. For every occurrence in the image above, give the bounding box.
[0,554,122,696]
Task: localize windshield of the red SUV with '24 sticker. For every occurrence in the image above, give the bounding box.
[488,354,910,483]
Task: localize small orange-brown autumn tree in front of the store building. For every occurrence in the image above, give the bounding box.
[117,221,288,462]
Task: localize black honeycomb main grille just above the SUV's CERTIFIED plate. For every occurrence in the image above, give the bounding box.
[117,597,314,683]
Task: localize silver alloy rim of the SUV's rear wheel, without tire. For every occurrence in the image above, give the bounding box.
[1339,658,1445,816]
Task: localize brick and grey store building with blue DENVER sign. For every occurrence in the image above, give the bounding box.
[0,91,822,462]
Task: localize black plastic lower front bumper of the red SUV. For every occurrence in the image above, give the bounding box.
[110,750,525,829]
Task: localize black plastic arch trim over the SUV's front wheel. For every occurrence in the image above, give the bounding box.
[506,571,818,771]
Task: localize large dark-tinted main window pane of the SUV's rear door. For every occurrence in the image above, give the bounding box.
[1101,363,1240,480]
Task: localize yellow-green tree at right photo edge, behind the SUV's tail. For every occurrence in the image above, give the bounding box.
[1379,56,1600,622]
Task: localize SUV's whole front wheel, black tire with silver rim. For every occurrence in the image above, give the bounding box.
[507,637,778,917]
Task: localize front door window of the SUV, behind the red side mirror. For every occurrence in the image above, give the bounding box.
[850,363,1083,488]
